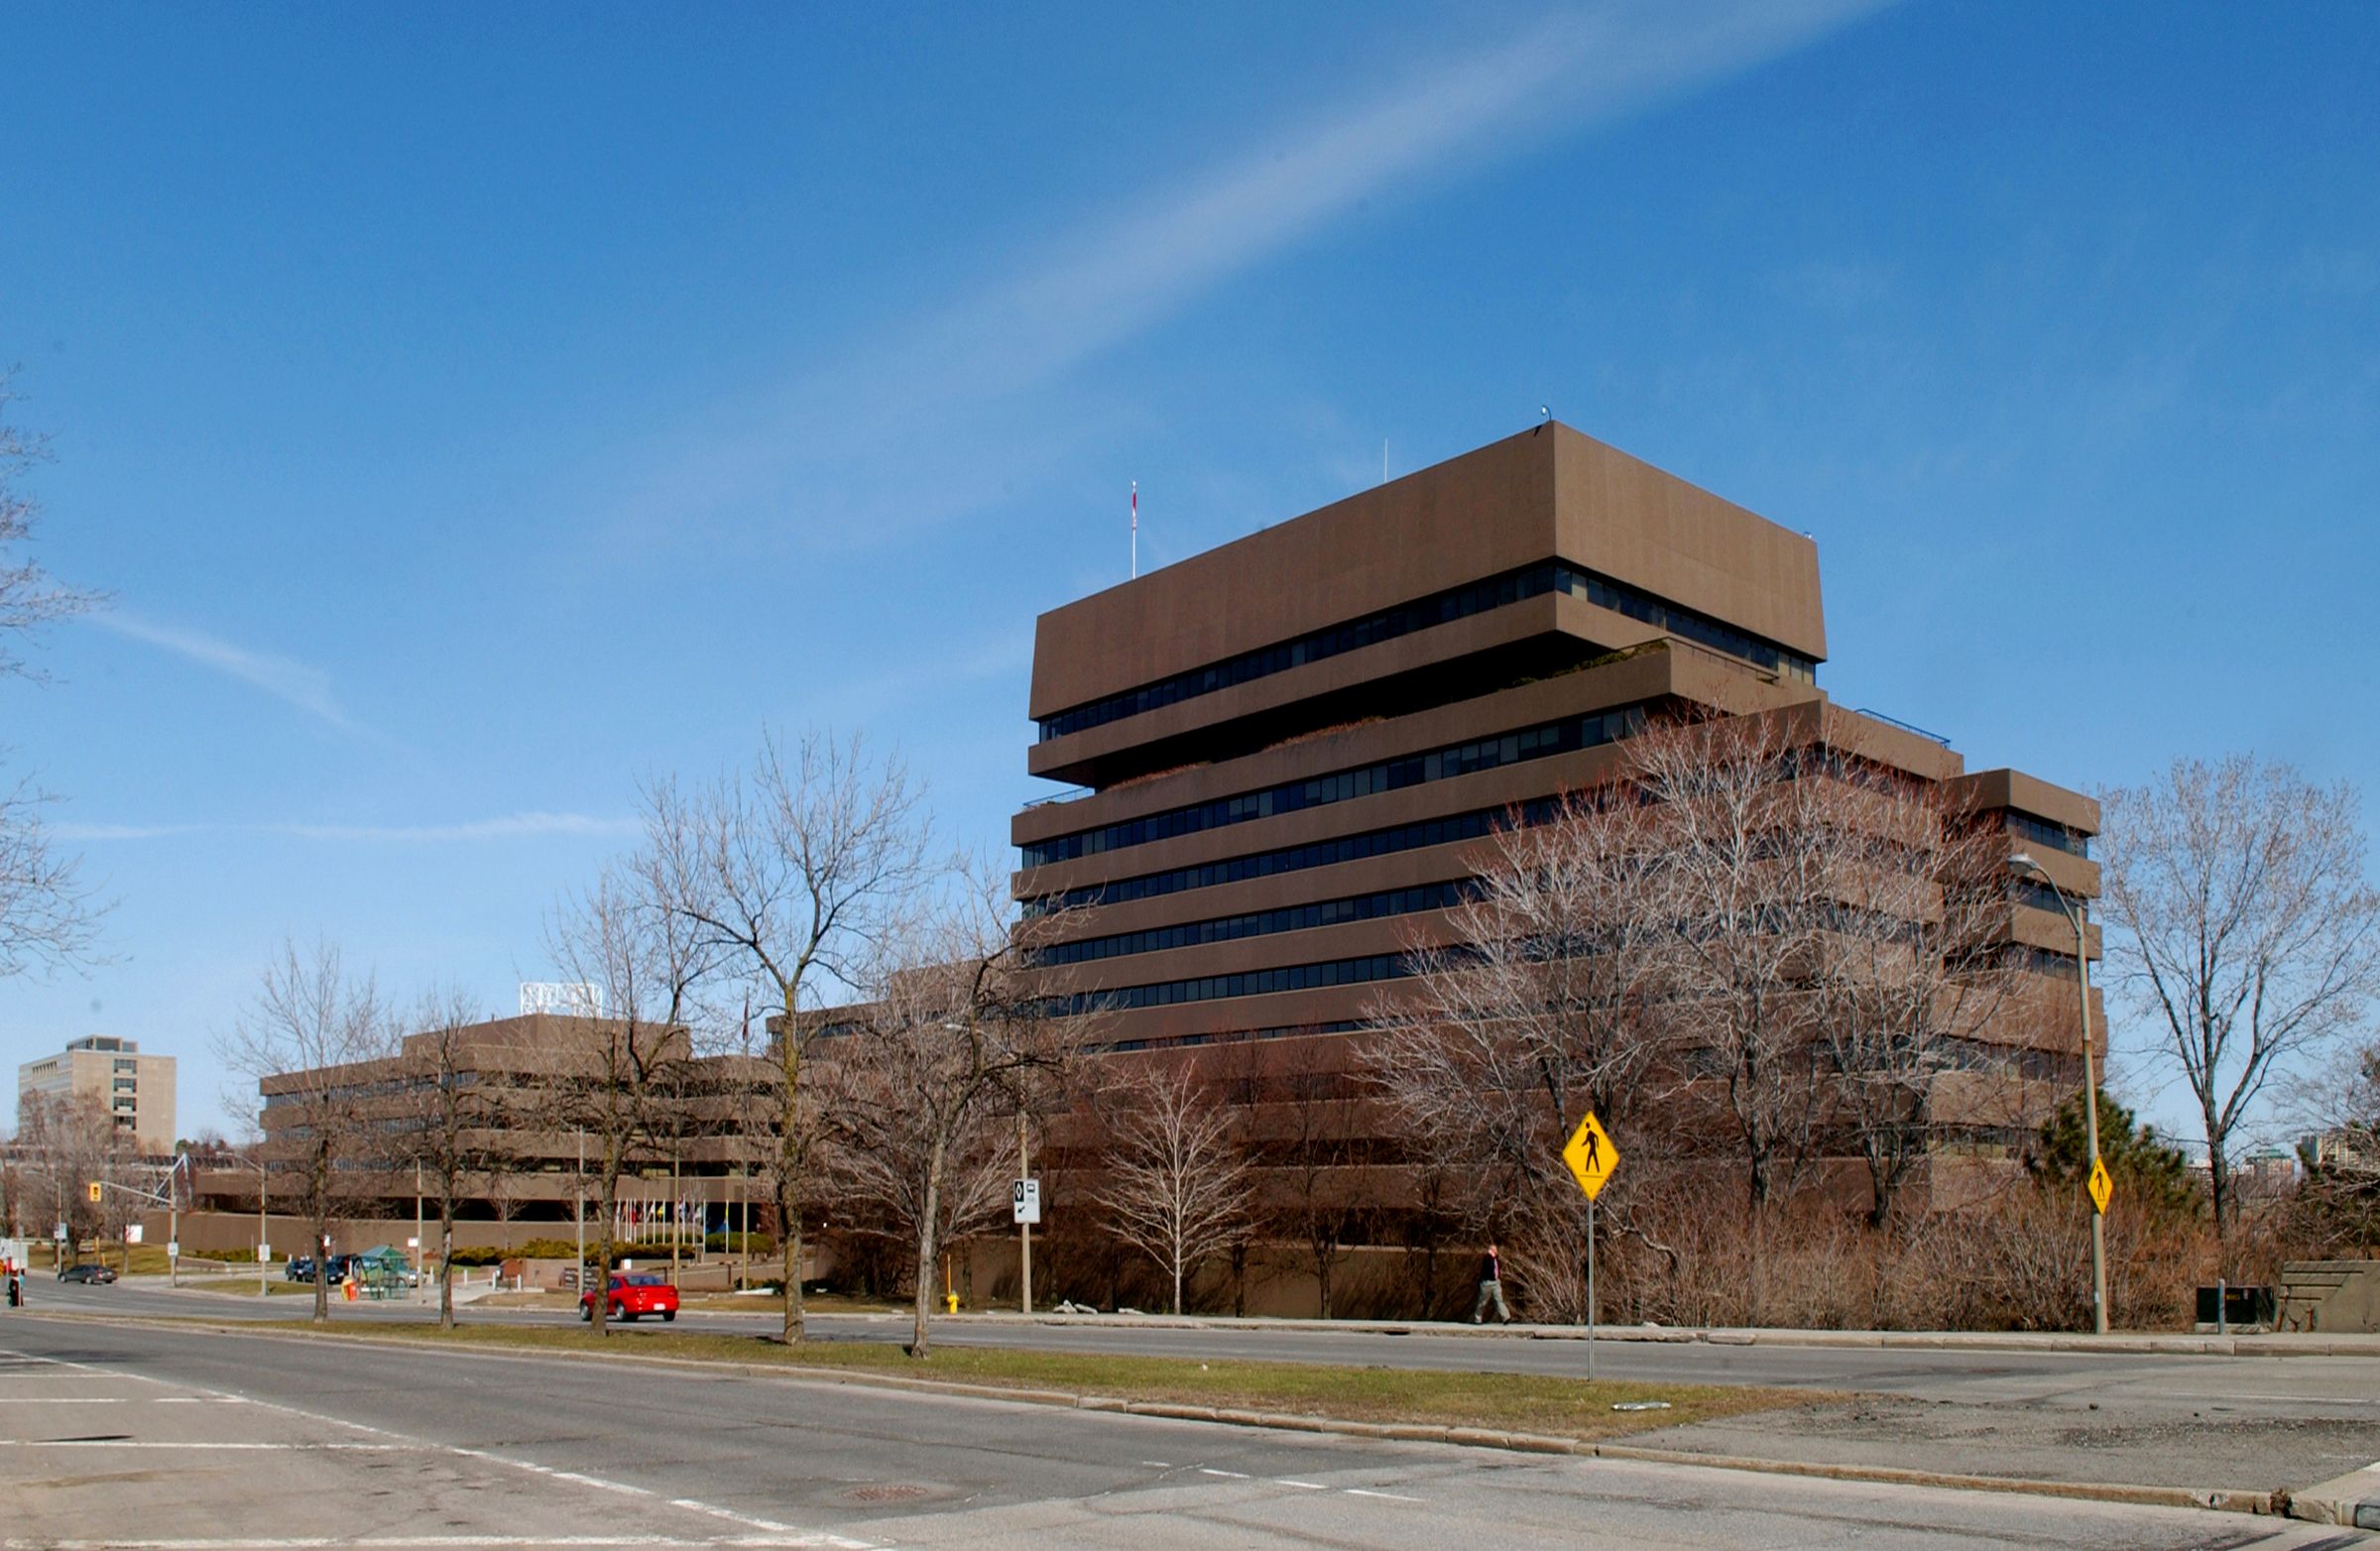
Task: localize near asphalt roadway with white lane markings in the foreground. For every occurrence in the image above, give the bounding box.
[0,1299,2368,1551]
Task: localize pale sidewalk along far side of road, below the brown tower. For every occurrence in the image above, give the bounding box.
[947,1311,2380,1359]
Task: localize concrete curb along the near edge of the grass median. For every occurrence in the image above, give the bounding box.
[9,1313,2294,1522]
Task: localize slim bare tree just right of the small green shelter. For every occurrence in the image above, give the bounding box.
[395,990,522,1328]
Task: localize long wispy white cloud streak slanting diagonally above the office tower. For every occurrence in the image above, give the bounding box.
[626,0,1880,542]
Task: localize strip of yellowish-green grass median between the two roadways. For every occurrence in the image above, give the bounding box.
[241,1323,1809,1442]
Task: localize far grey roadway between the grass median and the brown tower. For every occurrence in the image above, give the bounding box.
[36,1282,2380,1491]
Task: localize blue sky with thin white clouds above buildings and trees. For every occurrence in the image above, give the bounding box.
[0,0,2380,1133]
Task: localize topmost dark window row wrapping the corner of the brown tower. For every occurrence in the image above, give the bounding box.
[1037,561,1819,742]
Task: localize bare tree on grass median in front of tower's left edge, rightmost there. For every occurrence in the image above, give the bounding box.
[819,864,1069,1359]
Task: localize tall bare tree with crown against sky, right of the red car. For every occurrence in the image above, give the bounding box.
[670,733,926,1342]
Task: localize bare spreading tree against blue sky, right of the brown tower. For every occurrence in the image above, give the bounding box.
[2101,754,2380,1240]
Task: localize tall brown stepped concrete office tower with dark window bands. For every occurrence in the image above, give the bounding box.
[1012,423,2096,1213]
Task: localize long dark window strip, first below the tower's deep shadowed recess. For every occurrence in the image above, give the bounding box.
[1023,706,1644,869]
